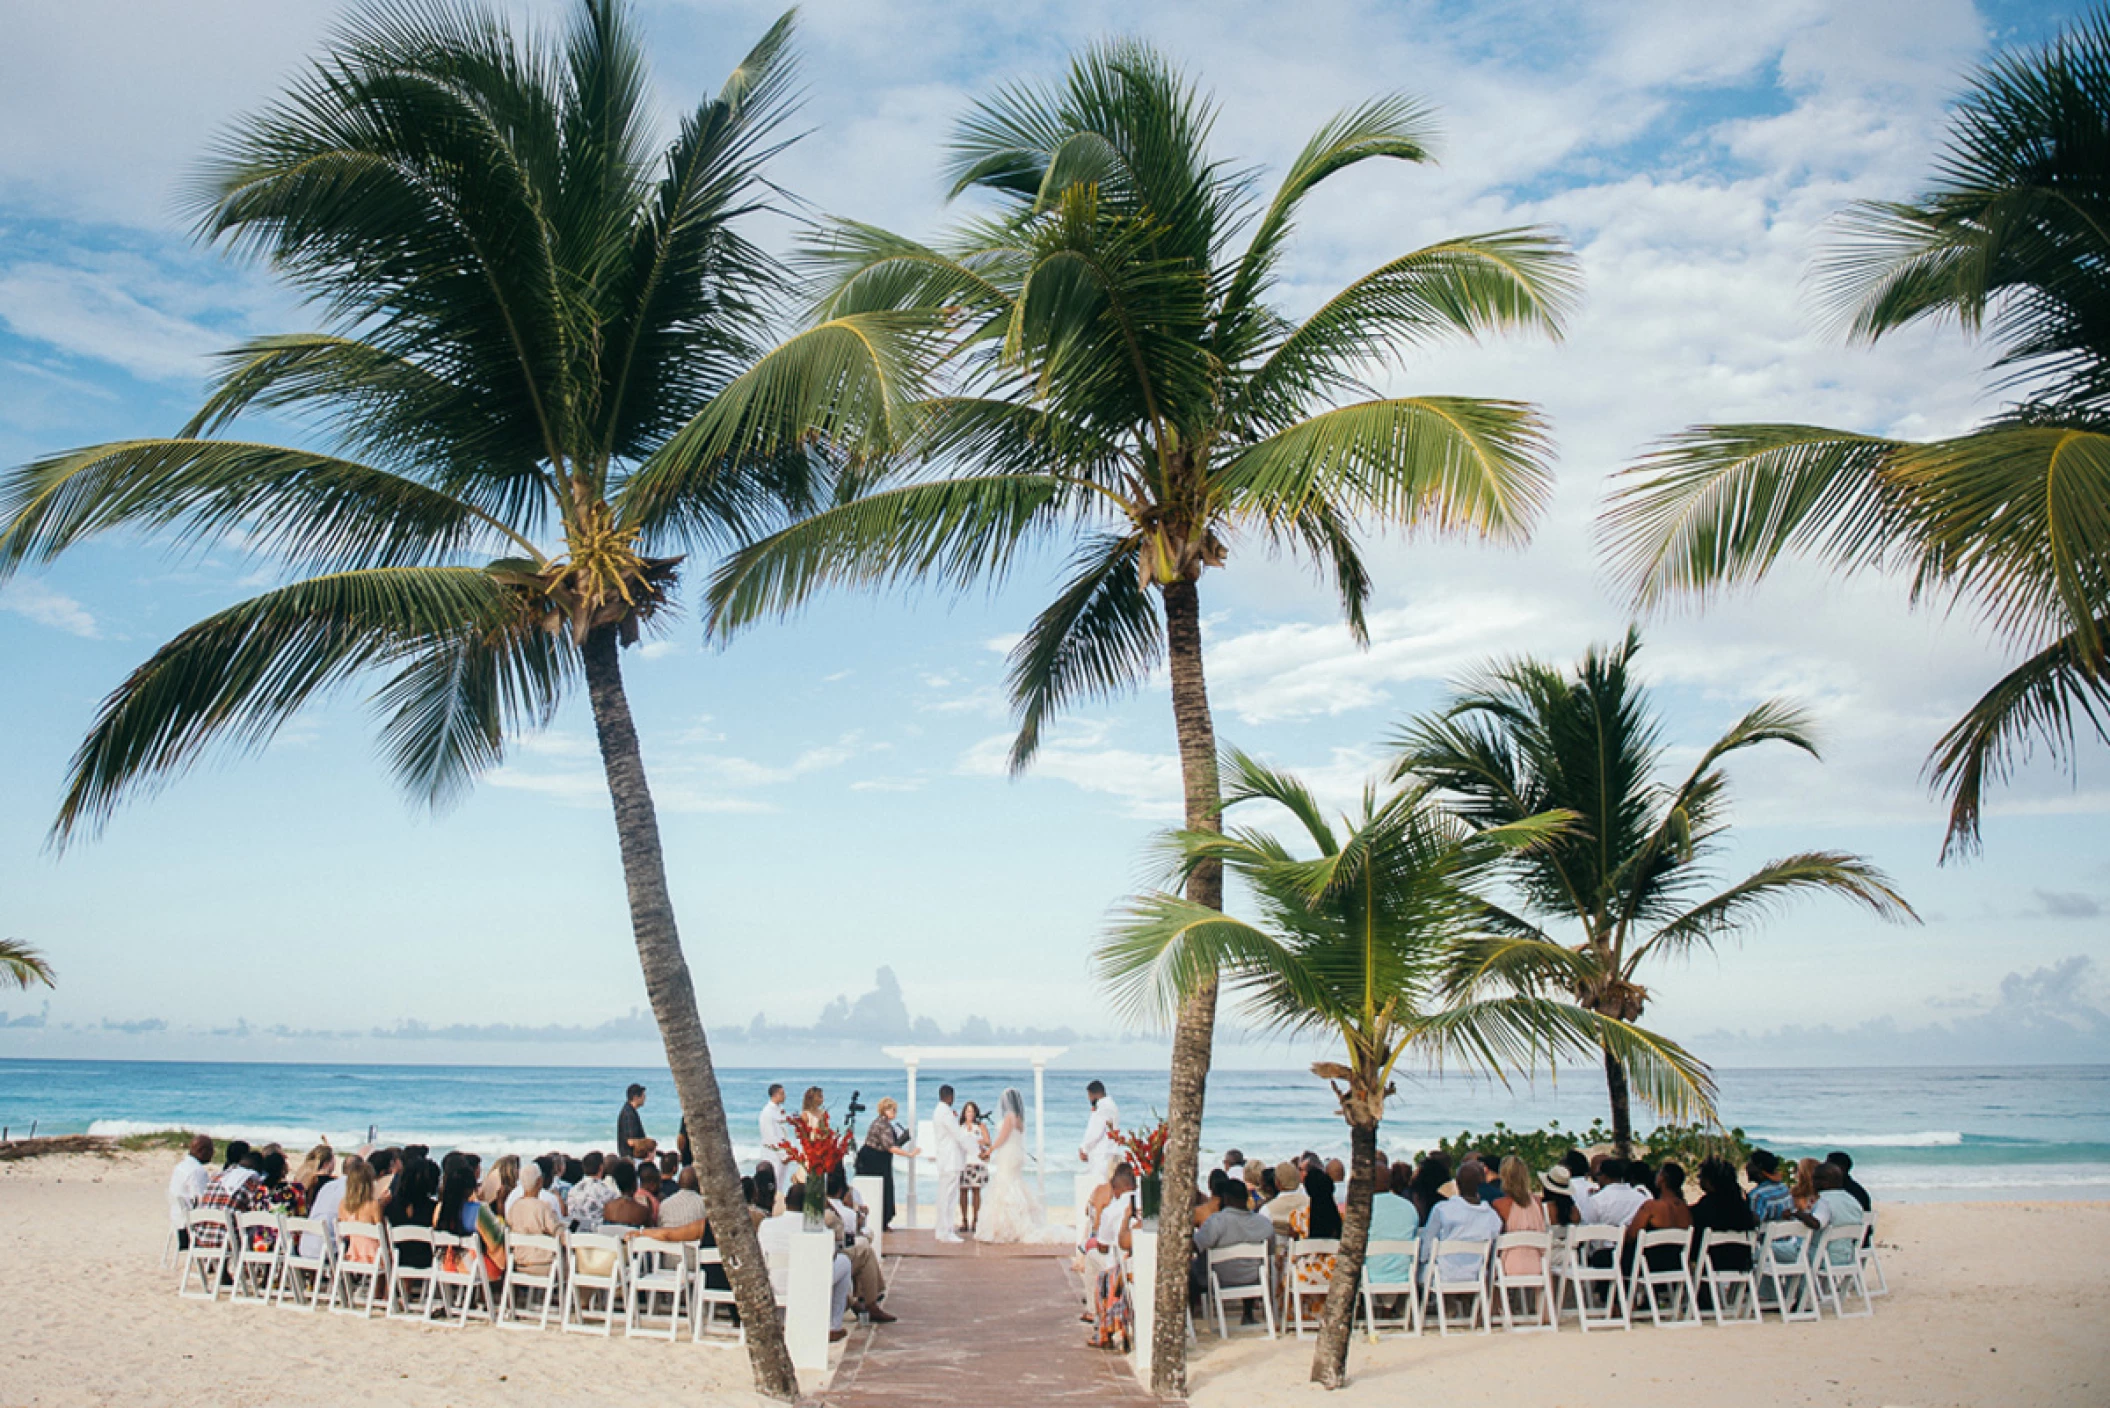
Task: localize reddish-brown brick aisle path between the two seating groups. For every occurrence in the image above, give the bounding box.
[821,1231,1158,1408]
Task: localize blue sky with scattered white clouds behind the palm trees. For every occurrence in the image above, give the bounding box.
[0,0,2110,1064]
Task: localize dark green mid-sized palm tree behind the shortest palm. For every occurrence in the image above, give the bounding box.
[1395,631,1918,1155]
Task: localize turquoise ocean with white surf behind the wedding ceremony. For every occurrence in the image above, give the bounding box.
[0,1060,2110,1201]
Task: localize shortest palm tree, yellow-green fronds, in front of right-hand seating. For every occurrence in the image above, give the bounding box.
[1097,754,1713,1389]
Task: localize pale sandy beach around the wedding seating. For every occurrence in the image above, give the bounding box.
[0,1153,2110,1408]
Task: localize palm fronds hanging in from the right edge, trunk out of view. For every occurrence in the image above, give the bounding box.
[1604,11,2110,861]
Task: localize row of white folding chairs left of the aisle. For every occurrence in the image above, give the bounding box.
[177,1207,745,1343]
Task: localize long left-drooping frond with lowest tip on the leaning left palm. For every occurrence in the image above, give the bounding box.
[53,568,517,844]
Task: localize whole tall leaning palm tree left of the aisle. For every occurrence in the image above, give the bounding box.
[0,0,810,1400]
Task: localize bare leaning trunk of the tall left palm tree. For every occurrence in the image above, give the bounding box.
[584,627,798,1402]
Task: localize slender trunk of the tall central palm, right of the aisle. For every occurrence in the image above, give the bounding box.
[1150,583,1224,1397]
